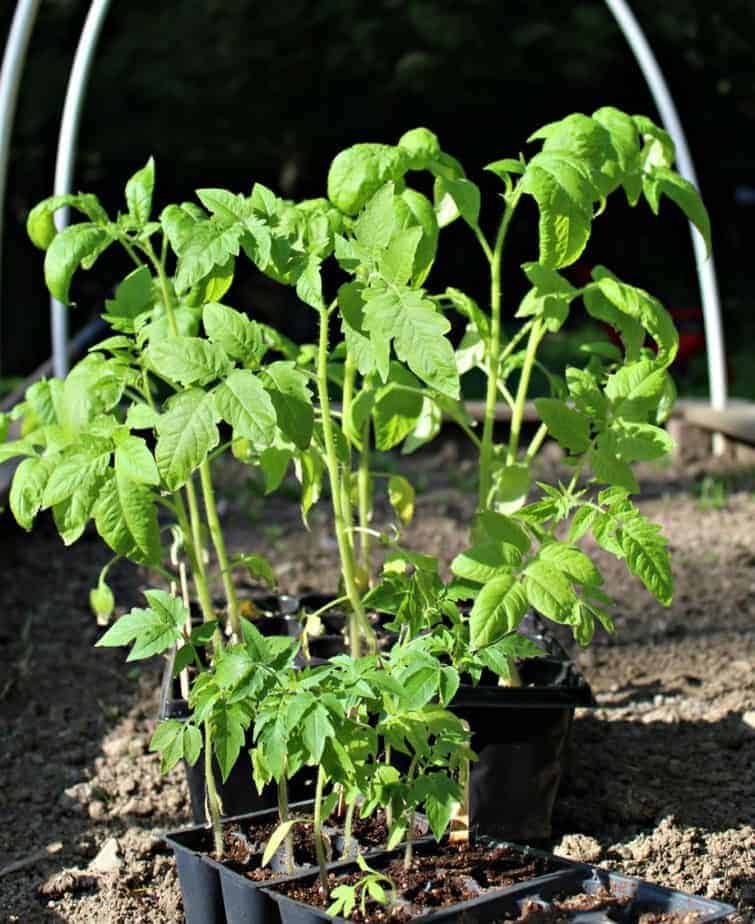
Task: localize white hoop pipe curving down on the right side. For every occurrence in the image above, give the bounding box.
[606,0,727,455]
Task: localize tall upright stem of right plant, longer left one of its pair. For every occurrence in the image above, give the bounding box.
[478,196,518,510]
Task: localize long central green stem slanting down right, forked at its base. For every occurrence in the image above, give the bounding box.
[317,310,376,658]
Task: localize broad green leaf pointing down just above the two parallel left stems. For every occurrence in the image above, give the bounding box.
[155,388,220,491]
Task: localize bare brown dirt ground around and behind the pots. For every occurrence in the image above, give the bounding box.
[0,443,755,924]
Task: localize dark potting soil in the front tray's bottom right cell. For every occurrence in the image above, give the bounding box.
[499,889,700,924]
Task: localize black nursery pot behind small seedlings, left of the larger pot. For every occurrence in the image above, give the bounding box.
[158,594,314,823]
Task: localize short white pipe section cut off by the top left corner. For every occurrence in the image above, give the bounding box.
[0,0,41,376]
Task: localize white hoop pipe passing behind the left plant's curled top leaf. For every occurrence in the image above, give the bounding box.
[50,0,110,378]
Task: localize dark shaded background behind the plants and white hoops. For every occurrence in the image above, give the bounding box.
[0,0,755,398]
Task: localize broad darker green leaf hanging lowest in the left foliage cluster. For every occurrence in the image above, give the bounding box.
[92,470,160,565]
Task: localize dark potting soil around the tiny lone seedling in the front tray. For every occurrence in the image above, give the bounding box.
[276,844,553,922]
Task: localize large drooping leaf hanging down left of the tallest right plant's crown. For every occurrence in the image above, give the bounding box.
[519,151,597,269]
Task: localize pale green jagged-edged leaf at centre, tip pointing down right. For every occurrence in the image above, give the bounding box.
[363,286,459,398]
